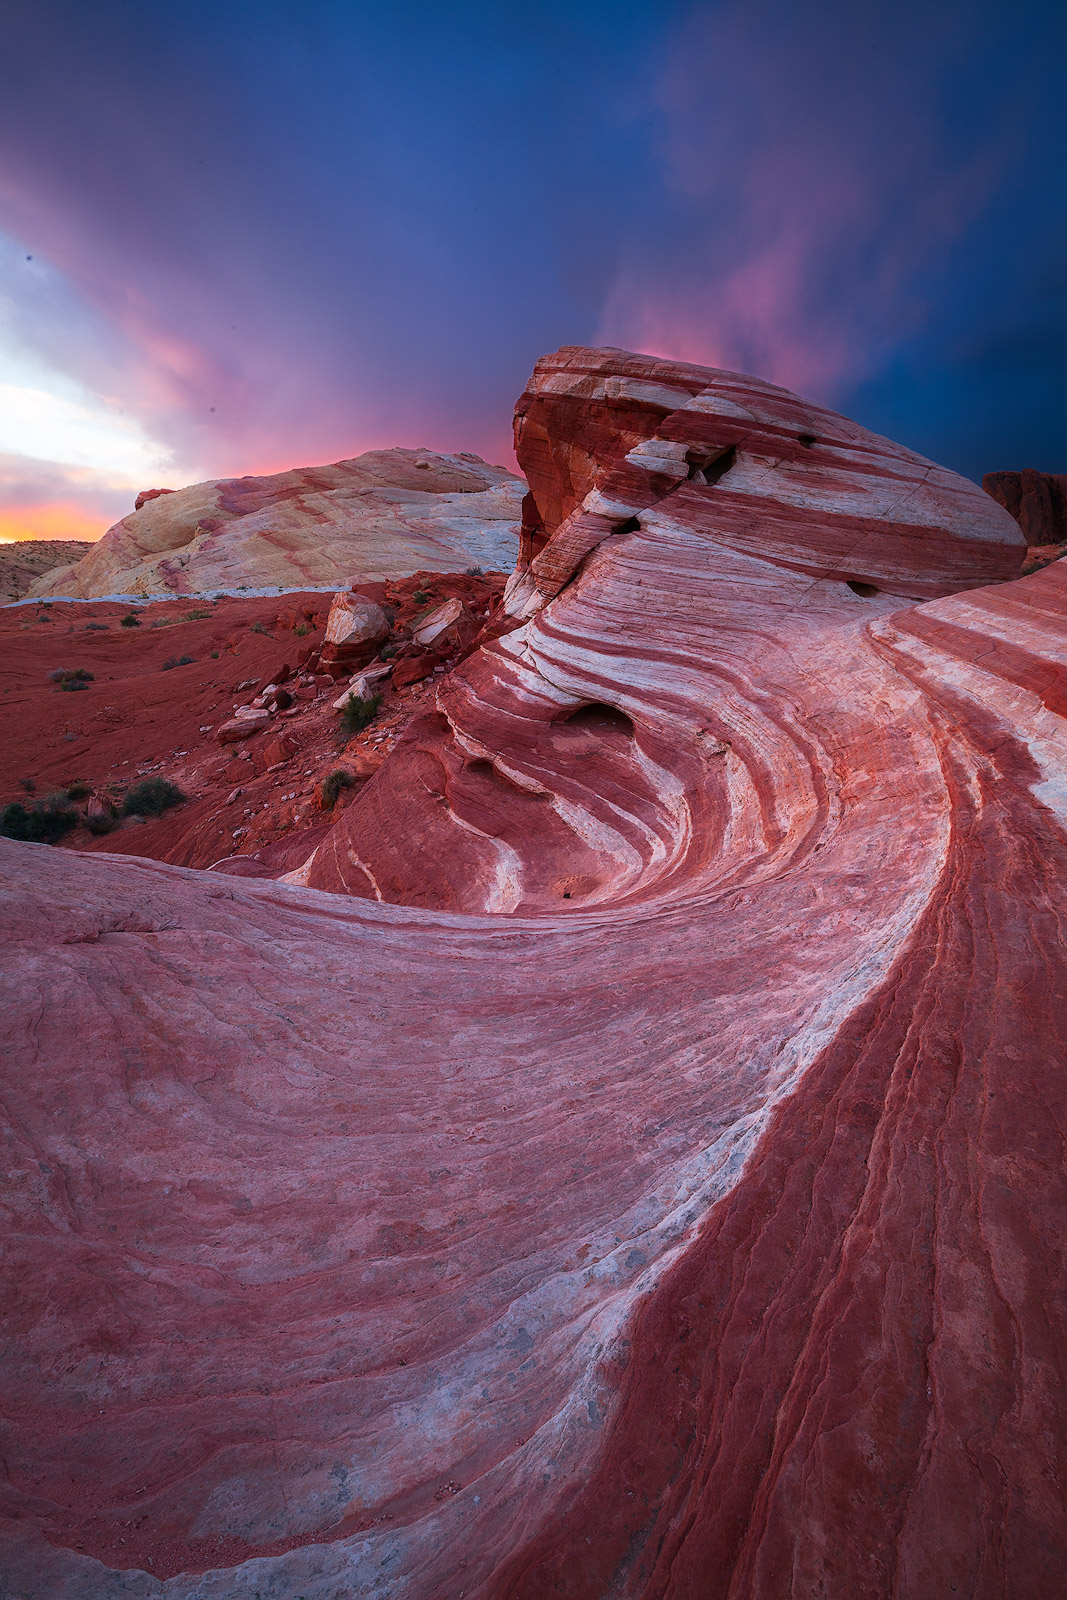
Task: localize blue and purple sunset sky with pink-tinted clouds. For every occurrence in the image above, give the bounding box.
[0,0,1067,539]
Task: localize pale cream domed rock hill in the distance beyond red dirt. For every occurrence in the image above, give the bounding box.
[29,450,525,600]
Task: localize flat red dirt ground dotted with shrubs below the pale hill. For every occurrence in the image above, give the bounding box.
[0,573,504,870]
